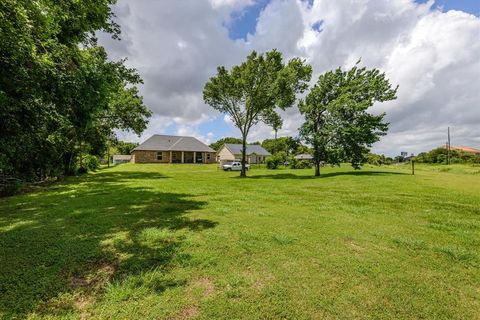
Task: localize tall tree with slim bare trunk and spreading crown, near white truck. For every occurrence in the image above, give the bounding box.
[203,50,312,177]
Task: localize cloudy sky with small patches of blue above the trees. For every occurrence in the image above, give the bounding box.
[99,0,480,156]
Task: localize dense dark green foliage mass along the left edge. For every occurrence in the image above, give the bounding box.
[0,0,150,180]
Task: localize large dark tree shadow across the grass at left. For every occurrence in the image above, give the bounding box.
[0,172,216,318]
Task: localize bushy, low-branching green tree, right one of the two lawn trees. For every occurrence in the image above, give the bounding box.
[299,61,398,176]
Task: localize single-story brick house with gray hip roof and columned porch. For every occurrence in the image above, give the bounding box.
[131,134,216,163]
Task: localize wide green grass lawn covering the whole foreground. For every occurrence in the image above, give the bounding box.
[0,164,480,319]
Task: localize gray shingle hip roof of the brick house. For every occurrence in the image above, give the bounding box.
[132,134,215,152]
